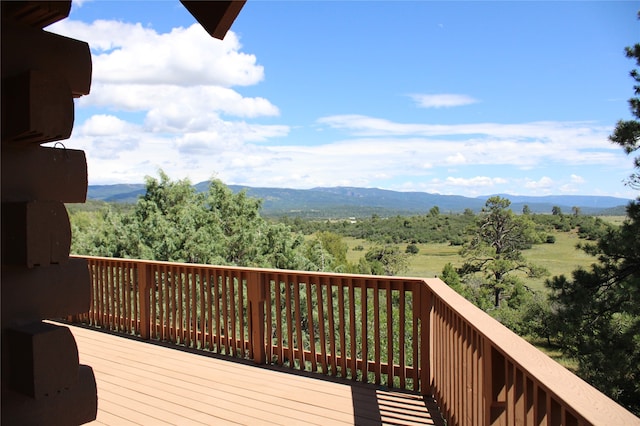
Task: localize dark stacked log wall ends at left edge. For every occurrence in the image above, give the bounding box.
[1,1,97,425]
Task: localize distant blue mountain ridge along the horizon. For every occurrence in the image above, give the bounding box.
[87,182,630,218]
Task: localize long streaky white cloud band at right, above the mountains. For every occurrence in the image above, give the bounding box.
[318,115,620,169]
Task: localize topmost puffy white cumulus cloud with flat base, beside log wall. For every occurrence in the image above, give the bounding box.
[48,20,264,87]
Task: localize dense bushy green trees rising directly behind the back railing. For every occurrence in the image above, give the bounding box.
[69,171,416,275]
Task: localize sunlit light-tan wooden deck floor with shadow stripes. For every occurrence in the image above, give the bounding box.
[70,326,443,426]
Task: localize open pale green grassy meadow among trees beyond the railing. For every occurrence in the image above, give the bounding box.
[343,232,595,290]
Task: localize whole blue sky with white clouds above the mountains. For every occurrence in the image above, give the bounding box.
[47,0,640,198]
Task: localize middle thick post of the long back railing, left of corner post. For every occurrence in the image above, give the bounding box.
[247,271,266,364]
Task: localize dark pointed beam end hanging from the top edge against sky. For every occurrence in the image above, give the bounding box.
[180,0,246,40]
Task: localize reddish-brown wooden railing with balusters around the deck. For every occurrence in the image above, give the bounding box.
[74,257,640,425]
